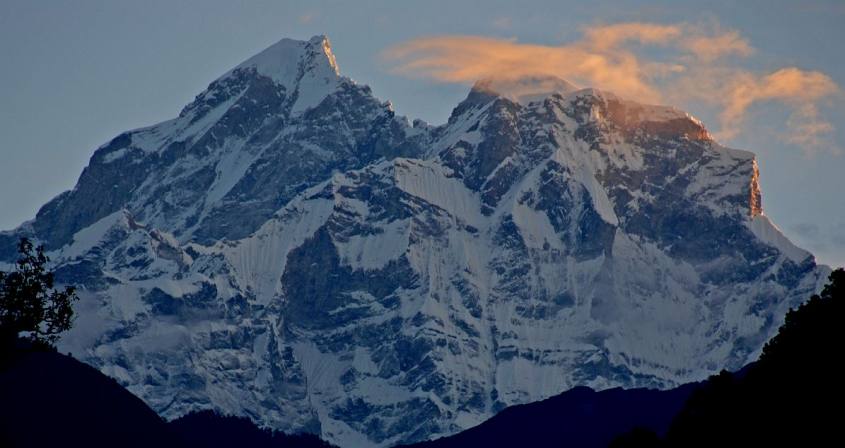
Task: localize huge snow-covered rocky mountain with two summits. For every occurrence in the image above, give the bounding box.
[0,36,829,446]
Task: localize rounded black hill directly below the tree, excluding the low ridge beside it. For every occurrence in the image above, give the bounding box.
[0,342,178,447]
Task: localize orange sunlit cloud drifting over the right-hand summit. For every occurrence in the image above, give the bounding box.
[383,22,841,153]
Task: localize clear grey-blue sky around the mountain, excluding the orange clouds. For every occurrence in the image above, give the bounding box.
[0,0,845,265]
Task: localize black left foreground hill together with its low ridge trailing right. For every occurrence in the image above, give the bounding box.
[0,344,332,448]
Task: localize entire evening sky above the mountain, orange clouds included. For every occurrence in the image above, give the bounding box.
[0,0,845,266]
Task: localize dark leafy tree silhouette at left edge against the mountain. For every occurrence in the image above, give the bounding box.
[0,238,78,346]
